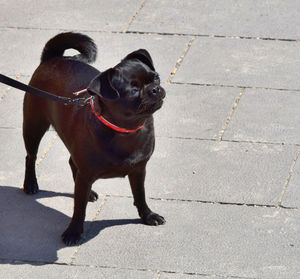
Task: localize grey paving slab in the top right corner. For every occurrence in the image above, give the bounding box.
[129,0,300,40]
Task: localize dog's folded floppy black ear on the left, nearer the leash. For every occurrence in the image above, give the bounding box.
[87,68,120,100]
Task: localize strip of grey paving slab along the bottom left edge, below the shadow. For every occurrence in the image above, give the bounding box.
[0,263,156,279]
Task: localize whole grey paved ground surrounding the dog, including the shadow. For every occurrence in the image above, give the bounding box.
[0,0,300,279]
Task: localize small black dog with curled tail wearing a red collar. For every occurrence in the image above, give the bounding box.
[23,32,165,245]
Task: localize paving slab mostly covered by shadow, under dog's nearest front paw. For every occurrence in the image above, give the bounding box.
[0,179,102,263]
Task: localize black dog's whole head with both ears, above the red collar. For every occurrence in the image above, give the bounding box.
[88,49,166,126]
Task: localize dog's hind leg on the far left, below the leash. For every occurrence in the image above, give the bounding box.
[23,93,50,194]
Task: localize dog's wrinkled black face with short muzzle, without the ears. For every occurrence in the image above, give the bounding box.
[111,59,166,117]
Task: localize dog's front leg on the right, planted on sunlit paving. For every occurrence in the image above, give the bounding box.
[128,165,166,226]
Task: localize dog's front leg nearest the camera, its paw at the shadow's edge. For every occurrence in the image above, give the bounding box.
[62,172,92,245]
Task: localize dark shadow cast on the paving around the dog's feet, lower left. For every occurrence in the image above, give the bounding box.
[0,186,141,264]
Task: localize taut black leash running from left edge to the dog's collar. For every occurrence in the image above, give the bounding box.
[0,74,90,106]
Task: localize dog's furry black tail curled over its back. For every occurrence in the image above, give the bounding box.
[41,32,97,63]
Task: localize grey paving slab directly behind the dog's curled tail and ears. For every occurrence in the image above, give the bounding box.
[0,29,190,81]
